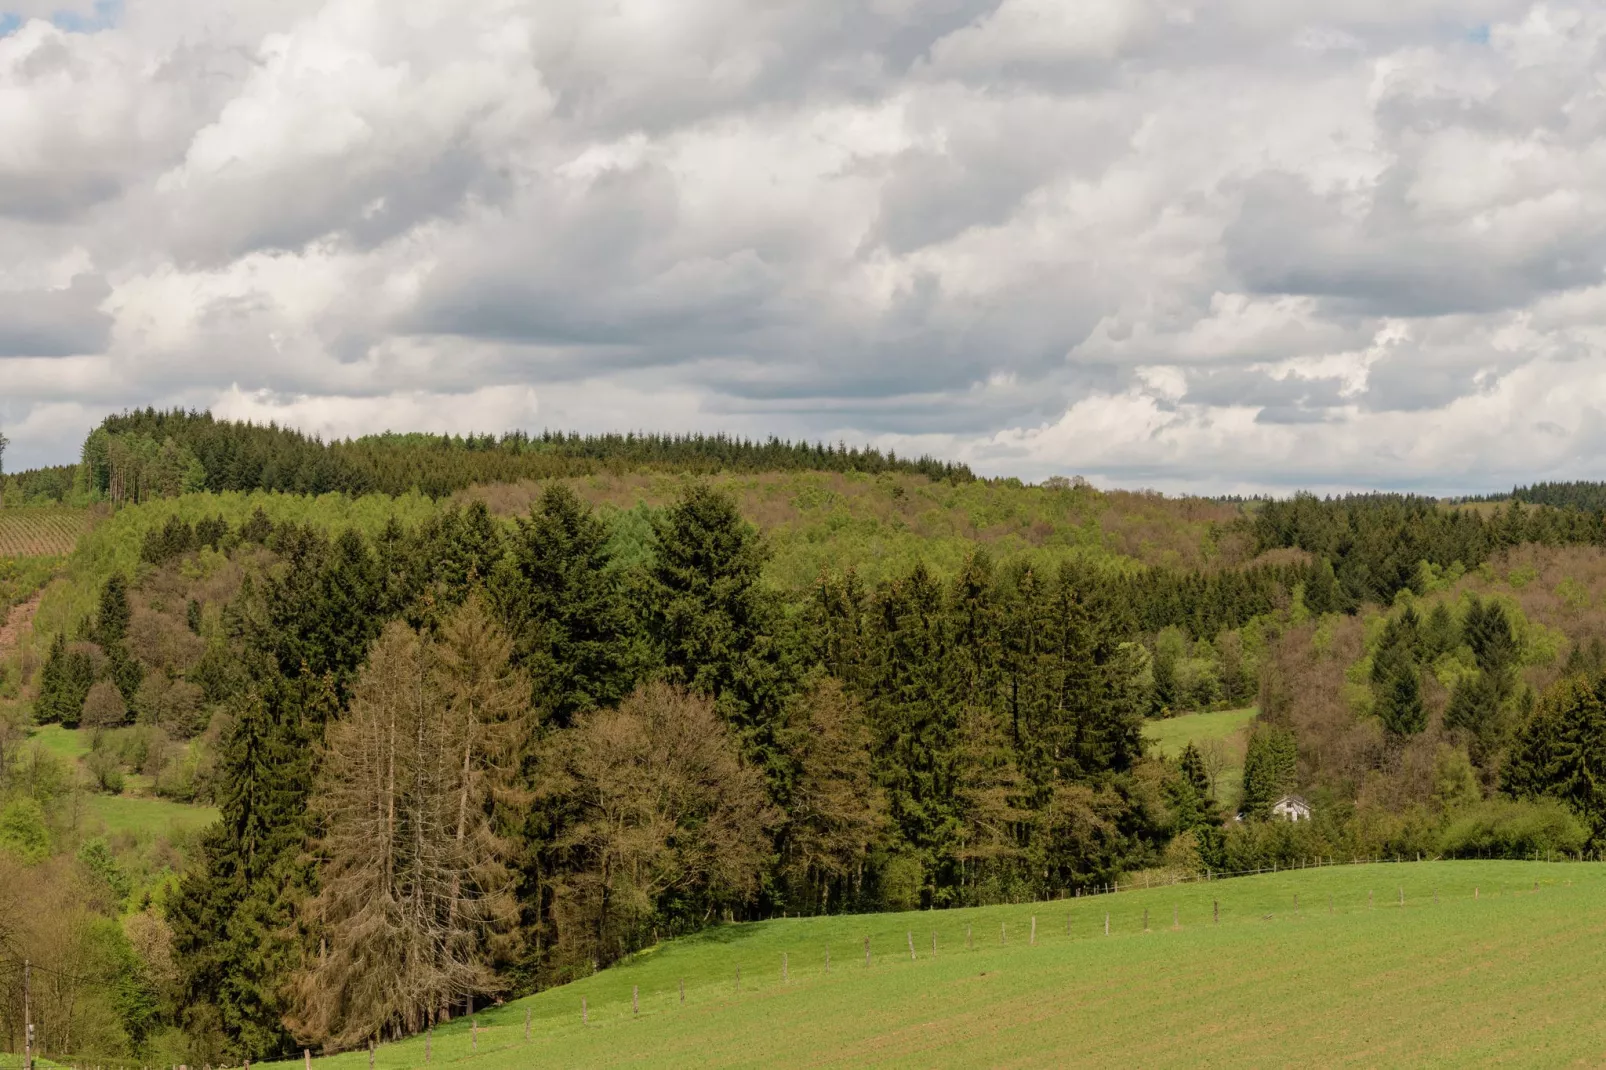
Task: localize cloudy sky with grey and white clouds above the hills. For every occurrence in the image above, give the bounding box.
[0,0,1606,493]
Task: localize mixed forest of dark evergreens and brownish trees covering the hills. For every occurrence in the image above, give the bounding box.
[0,413,1606,1065]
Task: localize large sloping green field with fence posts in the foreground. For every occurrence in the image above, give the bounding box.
[256,861,1606,1070]
